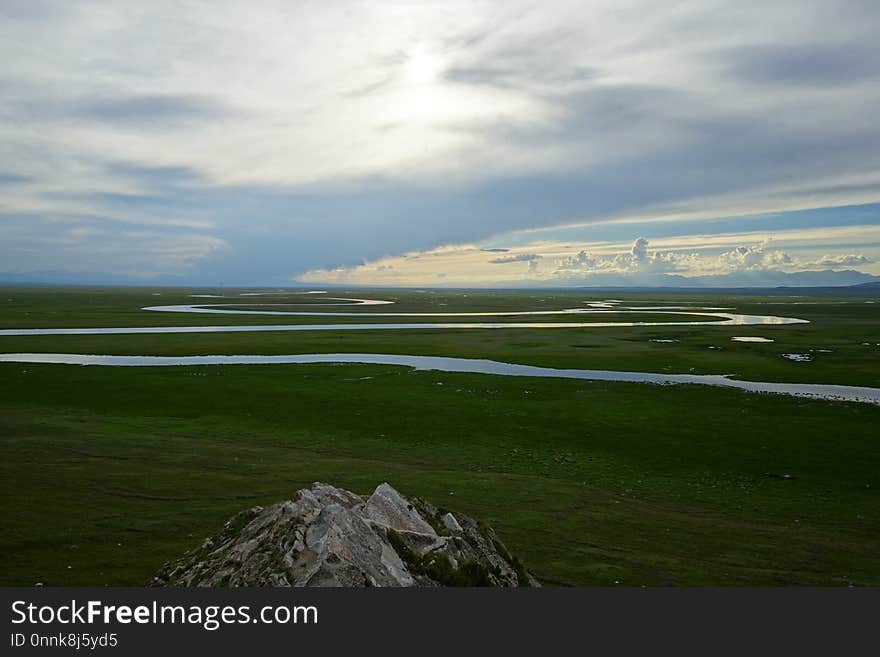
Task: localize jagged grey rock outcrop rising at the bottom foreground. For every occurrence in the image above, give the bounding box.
[150,483,537,586]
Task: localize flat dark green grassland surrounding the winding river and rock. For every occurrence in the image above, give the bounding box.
[0,288,880,585]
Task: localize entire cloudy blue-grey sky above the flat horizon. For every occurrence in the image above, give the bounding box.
[0,0,880,287]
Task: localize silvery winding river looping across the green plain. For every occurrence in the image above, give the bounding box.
[0,291,880,404]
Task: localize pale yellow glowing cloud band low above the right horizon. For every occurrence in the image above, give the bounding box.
[298,219,880,287]
